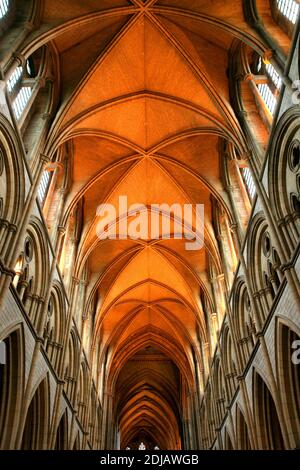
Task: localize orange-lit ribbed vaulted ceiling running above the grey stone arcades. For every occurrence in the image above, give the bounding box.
[24,0,286,446]
